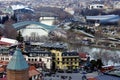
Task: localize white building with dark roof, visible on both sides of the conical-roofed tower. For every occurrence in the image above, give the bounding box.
[0,49,52,69]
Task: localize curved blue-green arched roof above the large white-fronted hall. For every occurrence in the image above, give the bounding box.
[12,21,56,31]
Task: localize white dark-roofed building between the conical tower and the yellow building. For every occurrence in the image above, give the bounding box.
[25,50,52,69]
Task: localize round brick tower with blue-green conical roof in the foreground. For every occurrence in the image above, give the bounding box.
[7,48,29,80]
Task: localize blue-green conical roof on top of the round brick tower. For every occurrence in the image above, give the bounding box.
[7,48,29,70]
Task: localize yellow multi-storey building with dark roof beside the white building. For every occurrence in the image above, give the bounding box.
[51,50,80,69]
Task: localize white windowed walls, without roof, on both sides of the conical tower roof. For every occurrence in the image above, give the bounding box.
[0,54,52,69]
